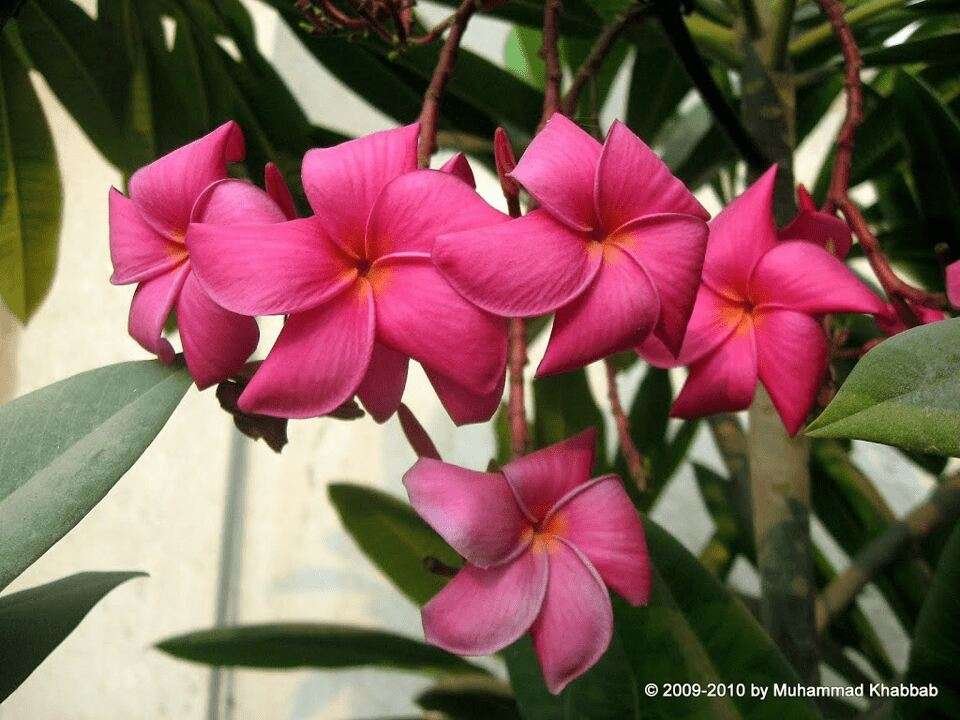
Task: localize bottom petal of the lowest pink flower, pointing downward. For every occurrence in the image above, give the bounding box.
[530,540,613,695]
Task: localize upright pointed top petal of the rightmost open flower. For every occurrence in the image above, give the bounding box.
[703,165,777,295]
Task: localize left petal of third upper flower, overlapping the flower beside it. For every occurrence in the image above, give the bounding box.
[433,210,601,317]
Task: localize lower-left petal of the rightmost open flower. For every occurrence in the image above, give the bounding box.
[670,317,757,418]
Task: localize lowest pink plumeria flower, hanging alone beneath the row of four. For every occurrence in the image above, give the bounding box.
[403,430,651,693]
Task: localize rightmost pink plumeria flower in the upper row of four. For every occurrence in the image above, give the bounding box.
[638,166,883,435]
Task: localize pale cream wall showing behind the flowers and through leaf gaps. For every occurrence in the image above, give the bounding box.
[0,0,944,720]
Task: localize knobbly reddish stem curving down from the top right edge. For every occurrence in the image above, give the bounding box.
[818,0,949,326]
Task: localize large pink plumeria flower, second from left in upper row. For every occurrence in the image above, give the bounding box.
[189,125,508,423]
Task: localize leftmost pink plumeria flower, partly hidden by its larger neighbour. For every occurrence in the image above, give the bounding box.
[110,122,286,388]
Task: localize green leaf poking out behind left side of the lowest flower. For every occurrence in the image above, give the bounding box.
[327,483,460,605]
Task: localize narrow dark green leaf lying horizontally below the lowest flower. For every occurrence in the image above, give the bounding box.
[157,623,486,675]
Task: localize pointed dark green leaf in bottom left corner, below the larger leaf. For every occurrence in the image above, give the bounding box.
[0,572,145,702]
